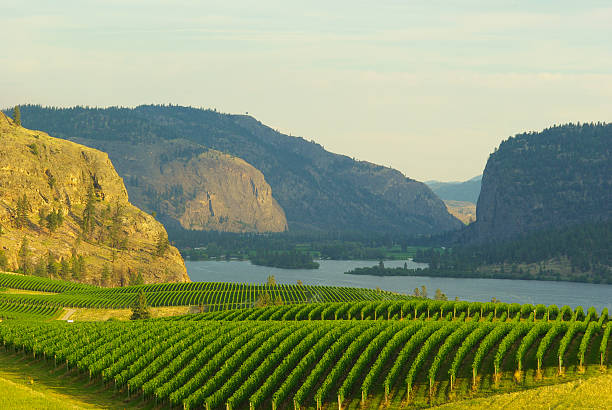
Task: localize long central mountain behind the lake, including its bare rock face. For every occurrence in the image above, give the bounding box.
[10,105,461,235]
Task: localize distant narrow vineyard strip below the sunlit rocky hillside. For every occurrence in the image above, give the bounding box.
[0,273,409,311]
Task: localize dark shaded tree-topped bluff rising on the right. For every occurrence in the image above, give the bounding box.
[470,124,612,241]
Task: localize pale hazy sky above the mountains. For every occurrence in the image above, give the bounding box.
[0,0,612,180]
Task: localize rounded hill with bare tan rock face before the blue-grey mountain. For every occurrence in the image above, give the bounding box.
[68,138,287,232]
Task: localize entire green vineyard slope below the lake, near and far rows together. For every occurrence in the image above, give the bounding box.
[0,275,612,410]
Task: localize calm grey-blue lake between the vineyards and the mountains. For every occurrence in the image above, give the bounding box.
[185,260,612,311]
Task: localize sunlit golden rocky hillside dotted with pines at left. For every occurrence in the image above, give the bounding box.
[0,113,189,285]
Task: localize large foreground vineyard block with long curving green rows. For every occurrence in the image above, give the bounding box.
[0,314,611,409]
